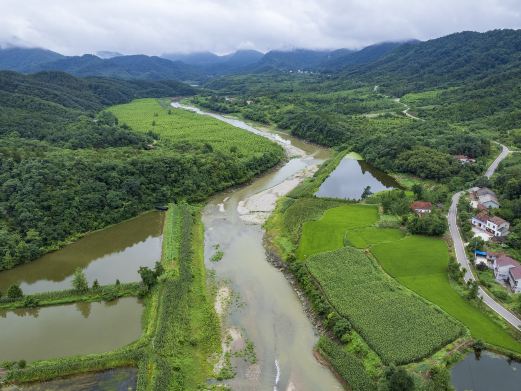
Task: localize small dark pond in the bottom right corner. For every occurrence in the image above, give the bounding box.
[452,352,521,391]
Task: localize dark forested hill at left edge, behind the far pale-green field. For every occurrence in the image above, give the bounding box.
[0,71,194,146]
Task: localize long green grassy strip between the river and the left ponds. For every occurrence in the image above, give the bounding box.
[142,205,220,390]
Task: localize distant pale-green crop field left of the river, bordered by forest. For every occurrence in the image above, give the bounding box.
[109,99,281,157]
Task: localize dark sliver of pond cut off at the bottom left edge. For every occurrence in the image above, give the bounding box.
[13,368,137,391]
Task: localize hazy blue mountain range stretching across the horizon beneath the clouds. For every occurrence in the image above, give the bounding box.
[0,30,521,89]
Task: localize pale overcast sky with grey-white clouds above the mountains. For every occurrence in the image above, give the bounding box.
[0,0,521,55]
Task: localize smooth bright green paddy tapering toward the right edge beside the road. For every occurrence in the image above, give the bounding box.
[371,236,521,353]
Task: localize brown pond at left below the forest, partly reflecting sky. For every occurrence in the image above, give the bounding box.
[0,212,163,294]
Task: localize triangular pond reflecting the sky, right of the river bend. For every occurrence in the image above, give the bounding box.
[316,154,400,200]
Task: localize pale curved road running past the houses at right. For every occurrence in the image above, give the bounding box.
[447,144,521,329]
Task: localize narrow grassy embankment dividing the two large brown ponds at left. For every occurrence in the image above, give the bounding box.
[0,282,142,310]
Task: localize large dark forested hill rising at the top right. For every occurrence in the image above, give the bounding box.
[342,30,521,95]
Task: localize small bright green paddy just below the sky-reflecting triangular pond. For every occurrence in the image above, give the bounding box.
[297,204,378,259]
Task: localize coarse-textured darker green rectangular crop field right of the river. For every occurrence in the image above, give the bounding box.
[306,248,464,364]
